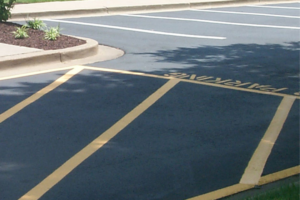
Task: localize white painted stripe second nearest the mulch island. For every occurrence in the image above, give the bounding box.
[121,14,300,30]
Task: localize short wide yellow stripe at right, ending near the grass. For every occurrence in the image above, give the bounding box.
[240,97,296,184]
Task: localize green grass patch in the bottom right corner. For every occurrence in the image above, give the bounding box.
[244,183,300,200]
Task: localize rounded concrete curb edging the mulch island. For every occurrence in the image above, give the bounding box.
[0,36,98,70]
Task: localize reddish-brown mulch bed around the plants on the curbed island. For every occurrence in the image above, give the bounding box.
[0,22,86,50]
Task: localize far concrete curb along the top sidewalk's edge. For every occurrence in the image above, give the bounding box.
[11,0,296,20]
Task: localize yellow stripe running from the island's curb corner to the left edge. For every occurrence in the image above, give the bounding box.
[0,67,83,123]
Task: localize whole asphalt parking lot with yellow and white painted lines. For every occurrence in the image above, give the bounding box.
[0,3,300,199]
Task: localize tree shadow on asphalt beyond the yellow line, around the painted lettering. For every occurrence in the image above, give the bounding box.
[135,42,300,92]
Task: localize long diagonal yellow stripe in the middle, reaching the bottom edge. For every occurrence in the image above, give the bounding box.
[20,79,179,200]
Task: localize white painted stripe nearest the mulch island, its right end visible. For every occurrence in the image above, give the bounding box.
[44,19,226,40]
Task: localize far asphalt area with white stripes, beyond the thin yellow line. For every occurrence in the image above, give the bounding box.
[40,3,299,83]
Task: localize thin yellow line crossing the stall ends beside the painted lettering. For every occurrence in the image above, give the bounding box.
[85,66,300,99]
